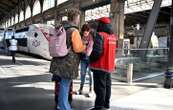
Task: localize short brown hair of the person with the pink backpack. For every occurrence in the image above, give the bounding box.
[67,8,81,21]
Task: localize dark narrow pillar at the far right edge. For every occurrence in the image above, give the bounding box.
[164,0,173,89]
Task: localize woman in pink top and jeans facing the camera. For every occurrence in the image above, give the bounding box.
[79,24,93,97]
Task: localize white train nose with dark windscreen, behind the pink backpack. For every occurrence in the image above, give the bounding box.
[6,24,54,59]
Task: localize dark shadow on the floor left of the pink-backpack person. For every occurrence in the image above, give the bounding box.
[0,75,54,110]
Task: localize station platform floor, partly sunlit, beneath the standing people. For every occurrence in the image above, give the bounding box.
[0,54,173,110]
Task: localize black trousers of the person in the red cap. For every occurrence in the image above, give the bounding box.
[93,70,111,109]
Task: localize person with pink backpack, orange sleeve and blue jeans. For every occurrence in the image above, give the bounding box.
[49,9,85,110]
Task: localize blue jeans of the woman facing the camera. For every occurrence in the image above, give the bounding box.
[80,60,92,87]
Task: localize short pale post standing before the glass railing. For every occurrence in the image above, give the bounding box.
[127,64,133,85]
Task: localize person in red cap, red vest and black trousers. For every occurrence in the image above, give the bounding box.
[90,17,116,110]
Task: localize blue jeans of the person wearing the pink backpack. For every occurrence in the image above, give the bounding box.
[58,78,71,110]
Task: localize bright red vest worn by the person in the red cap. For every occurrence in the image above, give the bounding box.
[90,32,116,73]
